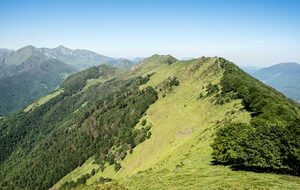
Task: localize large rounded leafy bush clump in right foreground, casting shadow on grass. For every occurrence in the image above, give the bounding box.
[212,121,300,175]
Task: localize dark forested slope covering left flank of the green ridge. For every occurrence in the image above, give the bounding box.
[0,65,157,189]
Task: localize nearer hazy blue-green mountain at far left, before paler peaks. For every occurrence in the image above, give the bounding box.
[0,46,75,115]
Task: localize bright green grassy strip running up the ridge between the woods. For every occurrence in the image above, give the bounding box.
[53,55,300,189]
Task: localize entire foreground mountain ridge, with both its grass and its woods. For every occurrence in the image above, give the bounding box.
[0,55,300,189]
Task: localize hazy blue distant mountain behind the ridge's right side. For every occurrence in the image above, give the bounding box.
[243,63,300,102]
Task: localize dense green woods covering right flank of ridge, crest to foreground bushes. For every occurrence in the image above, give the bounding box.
[208,59,300,175]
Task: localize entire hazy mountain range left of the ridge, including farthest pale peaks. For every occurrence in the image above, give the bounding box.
[0,45,135,115]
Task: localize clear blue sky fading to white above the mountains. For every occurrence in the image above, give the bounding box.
[0,0,300,66]
